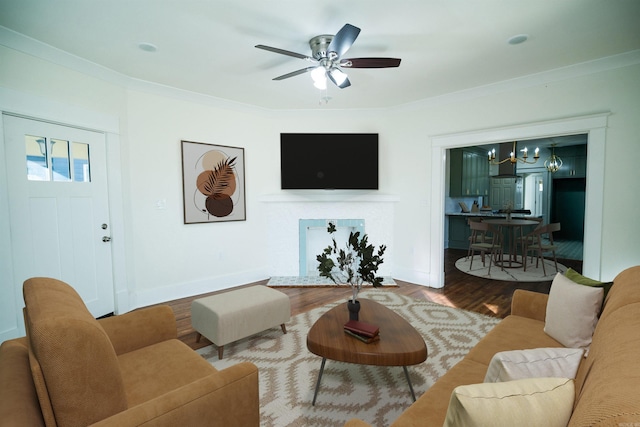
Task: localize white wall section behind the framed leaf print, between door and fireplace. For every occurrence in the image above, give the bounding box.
[124,91,274,305]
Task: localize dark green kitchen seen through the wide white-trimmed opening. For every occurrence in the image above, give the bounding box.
[444,137,587,261]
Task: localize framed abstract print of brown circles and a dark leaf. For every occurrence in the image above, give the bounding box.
[181,140,247,224]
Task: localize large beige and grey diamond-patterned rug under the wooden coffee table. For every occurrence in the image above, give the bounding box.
[198,289,499,427]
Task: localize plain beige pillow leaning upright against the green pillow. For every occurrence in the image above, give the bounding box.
[544,273,604,350]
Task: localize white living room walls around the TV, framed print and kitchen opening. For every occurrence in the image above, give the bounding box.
[0,47,640,332]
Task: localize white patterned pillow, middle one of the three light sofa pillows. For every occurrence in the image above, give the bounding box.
[484,347,584,383]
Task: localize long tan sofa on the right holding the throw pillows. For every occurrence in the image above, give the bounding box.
[345,266,640,427]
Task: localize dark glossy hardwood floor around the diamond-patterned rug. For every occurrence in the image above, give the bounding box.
[159,249,582,349]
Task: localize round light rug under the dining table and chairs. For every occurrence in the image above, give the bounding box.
[456,255,567,282]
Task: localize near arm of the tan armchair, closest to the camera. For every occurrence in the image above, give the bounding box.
[92,362,260,427]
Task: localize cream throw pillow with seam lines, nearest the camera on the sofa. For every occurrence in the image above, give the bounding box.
[444,378,575,427]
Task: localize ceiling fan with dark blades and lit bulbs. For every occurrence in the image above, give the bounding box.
[256,24,400,89]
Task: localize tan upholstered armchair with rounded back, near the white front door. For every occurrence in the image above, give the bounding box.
[0,278,260,427]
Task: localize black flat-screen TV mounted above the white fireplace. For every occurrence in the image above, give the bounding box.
[280,133,378,190]
